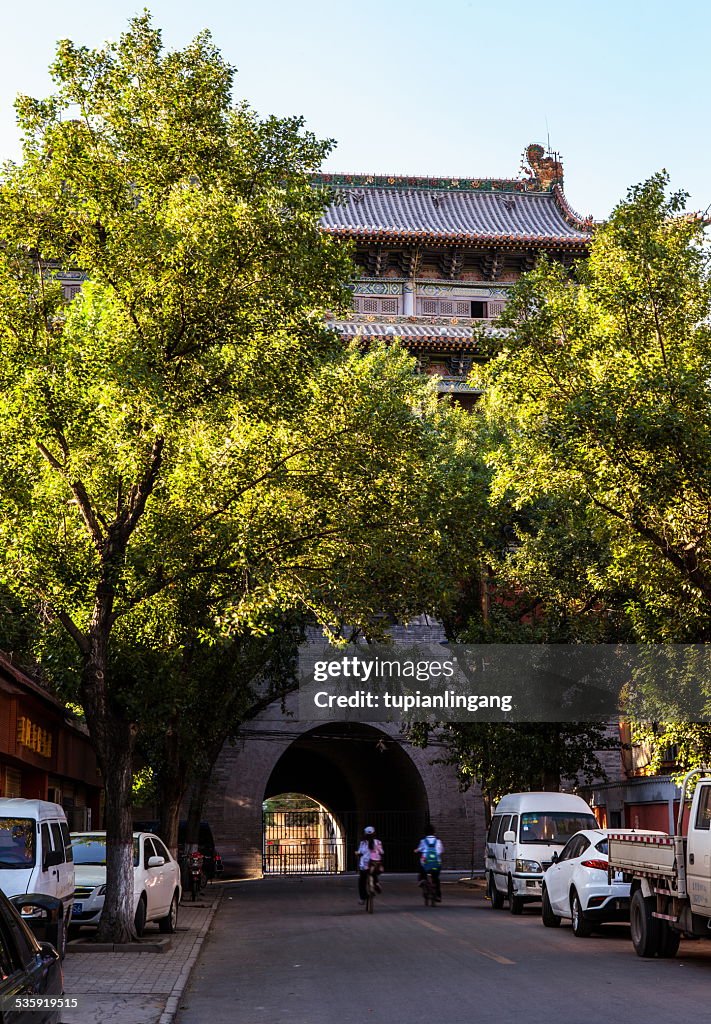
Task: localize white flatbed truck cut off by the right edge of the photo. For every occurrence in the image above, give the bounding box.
[609,768,711,956]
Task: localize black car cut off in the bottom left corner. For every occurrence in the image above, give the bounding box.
[0,892,64,1024]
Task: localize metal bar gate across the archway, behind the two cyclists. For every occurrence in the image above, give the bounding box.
[262,809,426,874]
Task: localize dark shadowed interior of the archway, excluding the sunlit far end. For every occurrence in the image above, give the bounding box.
[264,723,429,871]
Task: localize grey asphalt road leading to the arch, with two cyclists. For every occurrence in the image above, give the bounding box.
[177,876,711,1024]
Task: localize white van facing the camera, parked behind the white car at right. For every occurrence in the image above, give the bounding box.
[485,793,597,913]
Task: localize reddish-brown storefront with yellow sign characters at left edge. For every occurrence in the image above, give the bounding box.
[0,654,102,830]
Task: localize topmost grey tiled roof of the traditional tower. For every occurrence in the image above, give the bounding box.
[321,186,592,247]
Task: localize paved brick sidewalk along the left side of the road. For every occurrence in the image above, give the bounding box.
[60,884,223,1024]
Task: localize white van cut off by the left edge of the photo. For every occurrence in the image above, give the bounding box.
[0,798,74,953]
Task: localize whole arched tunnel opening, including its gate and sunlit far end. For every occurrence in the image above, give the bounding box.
[263,723,429,873]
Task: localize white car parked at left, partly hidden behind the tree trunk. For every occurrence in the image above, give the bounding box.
[72,833,181,935]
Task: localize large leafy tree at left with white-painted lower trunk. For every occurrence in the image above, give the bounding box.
[0,15,485,942]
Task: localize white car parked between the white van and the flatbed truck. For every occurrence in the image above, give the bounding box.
[541,828,629,937]
